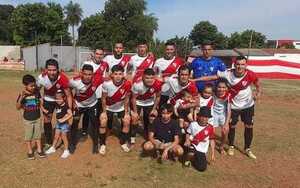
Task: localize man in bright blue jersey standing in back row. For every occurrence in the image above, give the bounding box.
[190,42,226,92]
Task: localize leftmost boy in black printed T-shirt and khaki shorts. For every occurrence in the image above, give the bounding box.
[16,74,45,159]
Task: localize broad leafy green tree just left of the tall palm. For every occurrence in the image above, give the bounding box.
[10,3,69,45]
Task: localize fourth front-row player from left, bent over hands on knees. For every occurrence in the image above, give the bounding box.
[131,68,163,144]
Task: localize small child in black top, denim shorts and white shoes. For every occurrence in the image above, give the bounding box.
[46,90,72,159]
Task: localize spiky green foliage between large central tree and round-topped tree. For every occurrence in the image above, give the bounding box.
[167,36,193,58]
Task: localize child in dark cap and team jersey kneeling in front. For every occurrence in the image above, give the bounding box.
[184,107,215,172]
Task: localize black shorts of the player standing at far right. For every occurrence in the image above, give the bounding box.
[230,105,254,126]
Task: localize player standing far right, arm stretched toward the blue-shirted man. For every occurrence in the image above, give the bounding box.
[201,56,261,159]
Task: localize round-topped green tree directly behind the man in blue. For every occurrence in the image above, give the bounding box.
[189,21,227,49]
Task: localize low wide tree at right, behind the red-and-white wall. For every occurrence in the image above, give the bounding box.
[228,30,266,48]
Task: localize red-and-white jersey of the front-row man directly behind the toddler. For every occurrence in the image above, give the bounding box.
[163,75,198,105]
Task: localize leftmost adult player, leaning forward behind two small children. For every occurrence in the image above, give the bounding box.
[37,59,73,149]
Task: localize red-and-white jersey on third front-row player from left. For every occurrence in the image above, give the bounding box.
[102,80,131,112]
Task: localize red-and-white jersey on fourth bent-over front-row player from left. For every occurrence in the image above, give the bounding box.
[132,80,163,106]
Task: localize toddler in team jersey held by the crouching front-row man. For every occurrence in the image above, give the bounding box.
[174,90,195,134]
